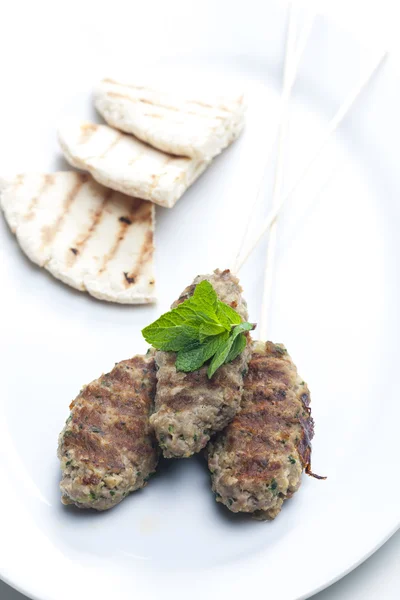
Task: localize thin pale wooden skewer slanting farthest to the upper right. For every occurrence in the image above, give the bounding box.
[235,51,387,273]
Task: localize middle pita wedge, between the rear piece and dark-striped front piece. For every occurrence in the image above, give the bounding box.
[58,121,208,208]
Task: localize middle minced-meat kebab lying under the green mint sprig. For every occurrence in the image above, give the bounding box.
[150,270,250,458]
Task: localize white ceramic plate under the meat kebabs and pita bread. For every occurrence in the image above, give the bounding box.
[0,0,400,600]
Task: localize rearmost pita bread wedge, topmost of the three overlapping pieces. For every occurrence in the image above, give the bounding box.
[94,77,245,160]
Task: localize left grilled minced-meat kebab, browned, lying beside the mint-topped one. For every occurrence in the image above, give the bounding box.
[58,354,158,510]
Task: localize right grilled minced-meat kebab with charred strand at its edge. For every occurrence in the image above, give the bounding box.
[207,342,314,519]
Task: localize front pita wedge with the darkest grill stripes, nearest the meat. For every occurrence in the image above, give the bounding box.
[0,171,155,304]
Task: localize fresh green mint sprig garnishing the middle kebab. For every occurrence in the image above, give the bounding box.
[142,281,255,378]
